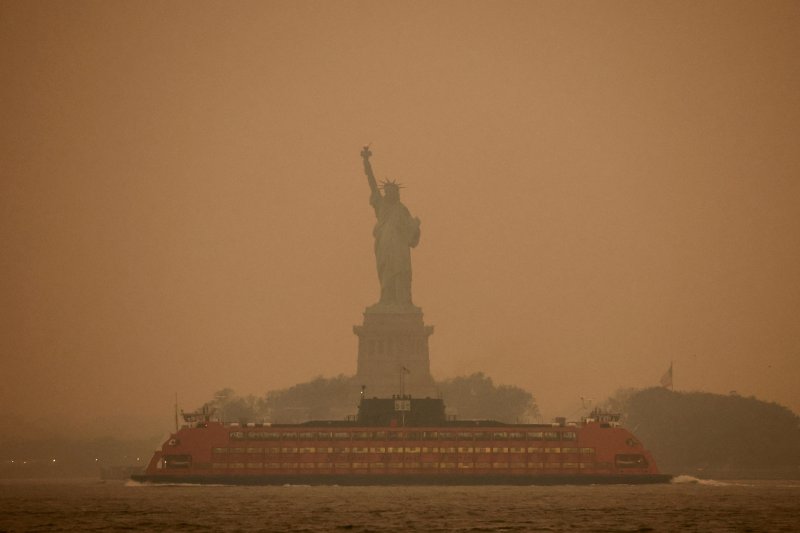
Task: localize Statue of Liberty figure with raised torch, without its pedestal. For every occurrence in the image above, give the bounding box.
[361,146,420,311]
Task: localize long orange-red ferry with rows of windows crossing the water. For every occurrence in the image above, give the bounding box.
[132,396,672,485]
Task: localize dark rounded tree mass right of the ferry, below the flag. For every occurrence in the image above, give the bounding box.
[607,388,800,478]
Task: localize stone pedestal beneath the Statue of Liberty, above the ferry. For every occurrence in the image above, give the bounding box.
[353,304,436,398]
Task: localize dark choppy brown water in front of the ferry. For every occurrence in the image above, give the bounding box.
[0,476,800,532]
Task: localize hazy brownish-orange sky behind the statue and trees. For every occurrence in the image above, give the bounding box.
[0,0,800,431]
